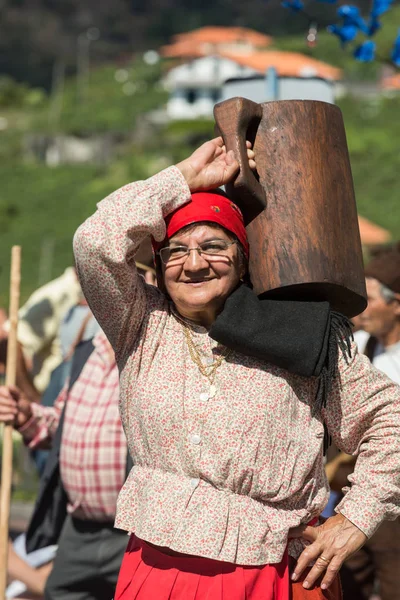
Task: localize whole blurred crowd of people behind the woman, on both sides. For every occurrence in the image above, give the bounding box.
[0,243,400,600]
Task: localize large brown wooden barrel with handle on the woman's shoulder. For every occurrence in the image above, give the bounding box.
[214,98,366,317]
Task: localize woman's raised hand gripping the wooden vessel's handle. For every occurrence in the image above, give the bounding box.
[176,137,256,192]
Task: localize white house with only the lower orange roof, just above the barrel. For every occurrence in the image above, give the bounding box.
[164,52,340,119]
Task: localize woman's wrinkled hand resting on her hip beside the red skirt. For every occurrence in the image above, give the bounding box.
[291,514,367,589]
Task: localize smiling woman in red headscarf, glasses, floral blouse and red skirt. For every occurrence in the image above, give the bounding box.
[74,138,400,600]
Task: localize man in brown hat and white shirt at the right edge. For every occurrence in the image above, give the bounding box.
[328,244,400,600]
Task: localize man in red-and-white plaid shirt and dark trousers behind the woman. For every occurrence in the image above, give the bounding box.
[0,332,128,600]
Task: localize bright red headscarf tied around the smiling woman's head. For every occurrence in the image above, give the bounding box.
[153,192,249,257]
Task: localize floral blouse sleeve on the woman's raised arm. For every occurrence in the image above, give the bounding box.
[74,167,190,356]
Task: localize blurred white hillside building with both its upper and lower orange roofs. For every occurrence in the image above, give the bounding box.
[160,27,342,119]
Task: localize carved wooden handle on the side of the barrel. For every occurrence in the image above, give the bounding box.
[214,98,267,225]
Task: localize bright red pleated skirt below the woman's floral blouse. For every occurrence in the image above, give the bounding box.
[115,535,289,600]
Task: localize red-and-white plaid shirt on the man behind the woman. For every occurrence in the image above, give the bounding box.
[20,332,127,521]
